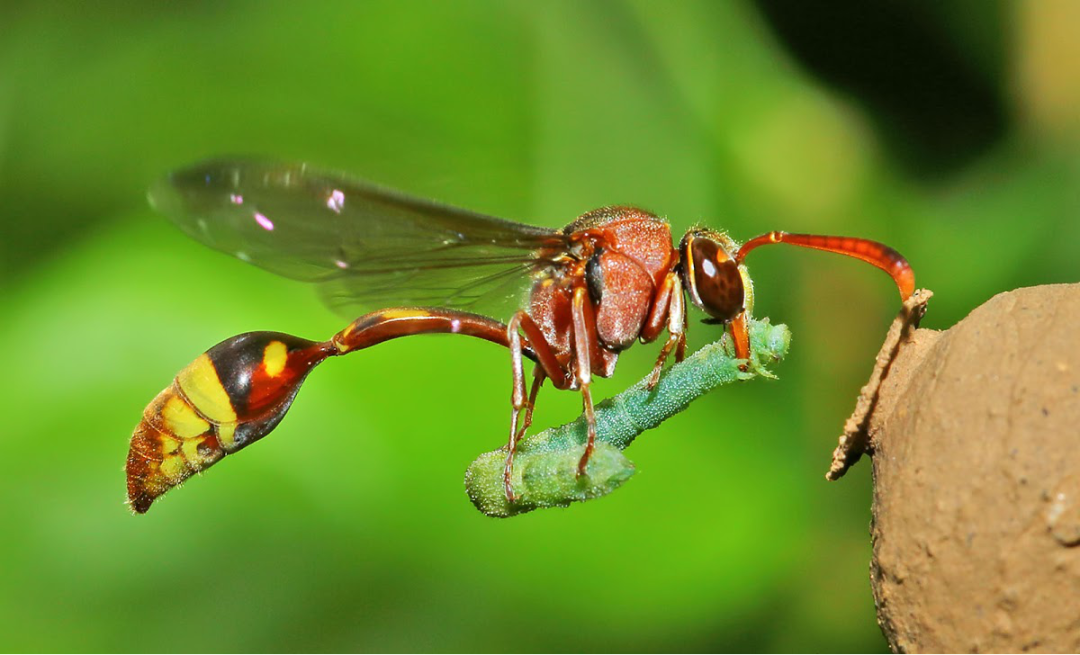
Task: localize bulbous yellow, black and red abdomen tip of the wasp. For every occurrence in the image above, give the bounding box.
[127,332,333,513]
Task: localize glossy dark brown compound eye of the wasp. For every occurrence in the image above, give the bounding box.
[680,231,746,323]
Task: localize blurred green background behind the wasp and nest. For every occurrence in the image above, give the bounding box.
[0,0,1080,654]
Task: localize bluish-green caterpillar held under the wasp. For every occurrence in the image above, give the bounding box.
[465,319,792,518]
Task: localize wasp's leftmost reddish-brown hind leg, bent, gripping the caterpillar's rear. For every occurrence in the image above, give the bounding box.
[502,310,572,503]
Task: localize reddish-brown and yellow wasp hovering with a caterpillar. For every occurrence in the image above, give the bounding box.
[126,160,915,513]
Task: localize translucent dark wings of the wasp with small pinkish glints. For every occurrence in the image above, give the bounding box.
[150,160,568,318]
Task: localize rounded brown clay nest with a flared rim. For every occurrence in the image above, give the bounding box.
[828,284,1080,654]
